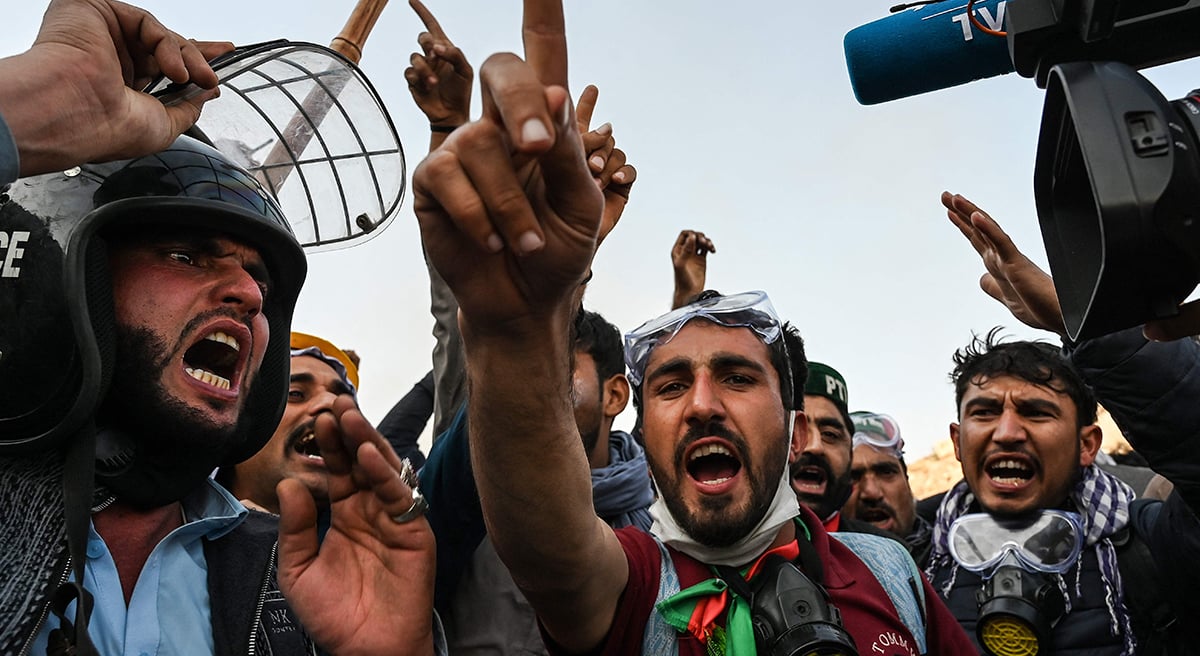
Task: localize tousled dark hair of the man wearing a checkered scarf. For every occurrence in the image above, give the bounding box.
[950,326,1096,428]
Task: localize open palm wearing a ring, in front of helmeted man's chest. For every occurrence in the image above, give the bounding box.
[277,395,436,655]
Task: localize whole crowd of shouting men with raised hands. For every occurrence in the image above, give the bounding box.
[0,0,1200,656]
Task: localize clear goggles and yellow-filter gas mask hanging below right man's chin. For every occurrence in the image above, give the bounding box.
[949,510,1084,656]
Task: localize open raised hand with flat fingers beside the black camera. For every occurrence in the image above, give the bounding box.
[942,192,1067,335]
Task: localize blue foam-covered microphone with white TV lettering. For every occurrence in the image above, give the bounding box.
[844,0,1014,104]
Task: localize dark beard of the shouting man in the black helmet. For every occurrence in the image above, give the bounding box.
[97,325,240,505]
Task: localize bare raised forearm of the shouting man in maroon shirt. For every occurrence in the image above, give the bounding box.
[463,311,628,650]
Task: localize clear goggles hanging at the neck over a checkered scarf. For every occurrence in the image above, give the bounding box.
[949,510,1084,574]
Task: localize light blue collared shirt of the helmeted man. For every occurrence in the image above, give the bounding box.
[30,479,246,656]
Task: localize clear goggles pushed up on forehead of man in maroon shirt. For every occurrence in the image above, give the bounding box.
[625,291,782,386]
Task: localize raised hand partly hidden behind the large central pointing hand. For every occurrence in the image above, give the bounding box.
[575,84,637,246]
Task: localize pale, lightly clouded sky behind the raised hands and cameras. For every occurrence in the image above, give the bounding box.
[9,0,1200,458]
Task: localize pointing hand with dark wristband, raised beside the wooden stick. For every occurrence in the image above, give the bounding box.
[404,0,475,127]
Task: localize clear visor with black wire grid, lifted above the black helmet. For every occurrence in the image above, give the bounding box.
[146,41,406,252]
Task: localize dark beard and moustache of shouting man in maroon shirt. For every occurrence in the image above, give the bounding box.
[647,423,787,548]
